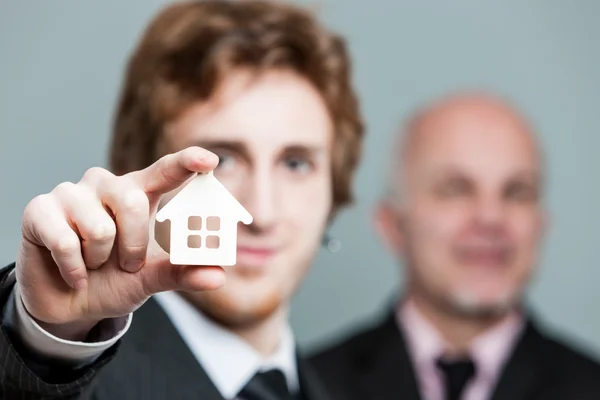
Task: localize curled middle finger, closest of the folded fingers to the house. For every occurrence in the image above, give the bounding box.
[98,177,150,272]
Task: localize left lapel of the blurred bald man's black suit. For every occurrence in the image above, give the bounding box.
[357,313,421,400]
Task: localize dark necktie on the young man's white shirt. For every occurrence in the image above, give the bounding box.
[238,369,293,400]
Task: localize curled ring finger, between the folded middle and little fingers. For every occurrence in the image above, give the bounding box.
[54,183,116,269]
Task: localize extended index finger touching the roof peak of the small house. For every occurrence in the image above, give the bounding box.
[131,147,219,200]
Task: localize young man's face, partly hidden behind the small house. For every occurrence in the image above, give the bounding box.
[156,71,333,326]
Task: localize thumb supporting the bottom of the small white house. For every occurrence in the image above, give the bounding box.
[139,253,225,295]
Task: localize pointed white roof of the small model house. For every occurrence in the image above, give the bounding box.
[156,171,252,225]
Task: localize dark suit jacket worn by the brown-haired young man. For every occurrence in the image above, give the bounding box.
[0,265,331,400]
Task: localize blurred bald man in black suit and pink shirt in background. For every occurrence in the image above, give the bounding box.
[312,94,600,400]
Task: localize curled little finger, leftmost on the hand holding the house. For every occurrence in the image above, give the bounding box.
[23,195,87,289]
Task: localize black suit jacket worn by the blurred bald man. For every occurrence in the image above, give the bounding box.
[310,313,600,400]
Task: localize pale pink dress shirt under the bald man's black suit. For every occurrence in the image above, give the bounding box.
[397,300,524,400]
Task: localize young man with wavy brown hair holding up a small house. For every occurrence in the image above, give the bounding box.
[0,1,363,400]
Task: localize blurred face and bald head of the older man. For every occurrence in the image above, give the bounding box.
[381,103,543,315]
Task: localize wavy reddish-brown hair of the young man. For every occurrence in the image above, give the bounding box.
[109,0,364,214]
